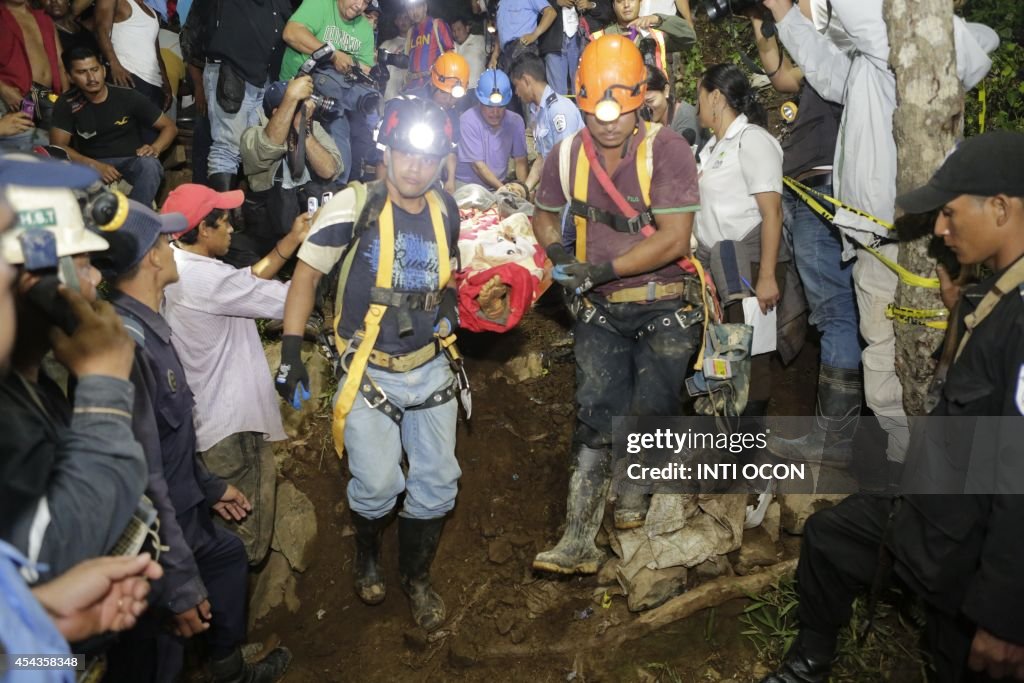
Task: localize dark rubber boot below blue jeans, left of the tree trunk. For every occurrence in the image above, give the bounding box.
[768,366,863,467]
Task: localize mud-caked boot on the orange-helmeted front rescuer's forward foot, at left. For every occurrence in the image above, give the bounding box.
[534,445,611,574]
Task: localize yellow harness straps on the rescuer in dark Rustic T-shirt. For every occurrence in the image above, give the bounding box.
[332,188,461,458]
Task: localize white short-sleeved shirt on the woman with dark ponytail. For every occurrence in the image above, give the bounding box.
[695,115,782,248]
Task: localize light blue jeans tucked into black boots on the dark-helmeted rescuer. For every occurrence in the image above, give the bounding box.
[335,354,462,519]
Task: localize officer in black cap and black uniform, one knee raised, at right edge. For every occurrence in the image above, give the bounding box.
[763,131,1024,683]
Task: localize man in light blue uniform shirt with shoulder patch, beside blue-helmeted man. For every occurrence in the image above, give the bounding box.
[509,54,583,195]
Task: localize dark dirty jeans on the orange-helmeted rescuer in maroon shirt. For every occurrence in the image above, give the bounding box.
[572,297,703,449]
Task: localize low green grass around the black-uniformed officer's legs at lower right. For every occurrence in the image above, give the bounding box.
[739,581,926,683]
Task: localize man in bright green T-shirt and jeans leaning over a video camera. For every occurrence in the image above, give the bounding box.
[281,0,375,183]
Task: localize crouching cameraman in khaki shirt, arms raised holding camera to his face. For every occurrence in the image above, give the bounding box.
[241,76,344,265]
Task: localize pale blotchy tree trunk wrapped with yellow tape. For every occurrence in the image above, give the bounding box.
[885,0,964,415]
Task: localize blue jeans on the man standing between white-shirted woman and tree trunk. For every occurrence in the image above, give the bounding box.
[782,184,860,370]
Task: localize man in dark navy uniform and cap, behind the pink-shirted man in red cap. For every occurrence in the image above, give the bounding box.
[103,202,292,683]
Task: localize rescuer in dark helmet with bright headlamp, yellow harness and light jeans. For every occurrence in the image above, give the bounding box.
[276,97,462,631]
